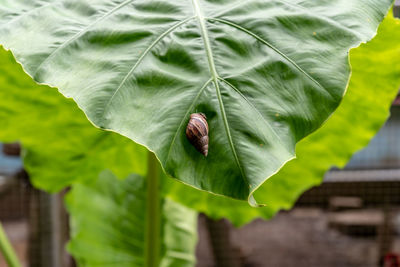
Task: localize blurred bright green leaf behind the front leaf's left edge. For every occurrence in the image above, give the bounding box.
[0,47,146,192]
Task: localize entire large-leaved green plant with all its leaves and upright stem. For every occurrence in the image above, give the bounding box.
[0,0,400,266]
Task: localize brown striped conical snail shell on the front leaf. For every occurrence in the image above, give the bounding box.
[186,113,208,157]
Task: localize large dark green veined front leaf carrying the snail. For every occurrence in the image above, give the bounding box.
[0,0,392,202]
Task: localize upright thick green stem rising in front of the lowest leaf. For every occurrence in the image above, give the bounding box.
[145,151,161,267]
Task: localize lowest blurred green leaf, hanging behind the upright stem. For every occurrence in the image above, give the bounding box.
[66,172,197,267]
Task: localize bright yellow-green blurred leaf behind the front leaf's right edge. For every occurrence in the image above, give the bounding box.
[169,11,400,225]
